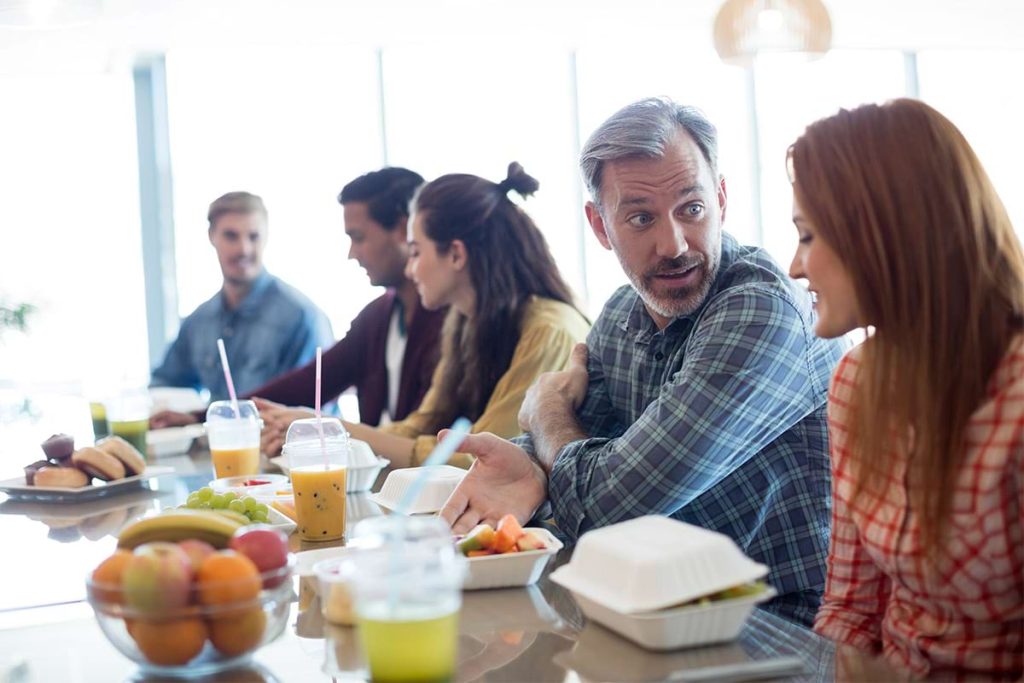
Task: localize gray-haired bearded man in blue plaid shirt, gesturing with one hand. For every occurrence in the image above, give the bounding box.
[441,99,844,626]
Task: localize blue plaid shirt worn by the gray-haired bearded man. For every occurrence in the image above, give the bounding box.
[517,234,846,625]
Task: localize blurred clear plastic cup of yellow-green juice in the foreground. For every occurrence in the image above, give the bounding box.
[350,516,466,682]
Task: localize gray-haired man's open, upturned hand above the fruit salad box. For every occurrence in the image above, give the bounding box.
[437,429,548,533]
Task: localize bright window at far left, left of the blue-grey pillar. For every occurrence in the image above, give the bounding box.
[0,72,148,391]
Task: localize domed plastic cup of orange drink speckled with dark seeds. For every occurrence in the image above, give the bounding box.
[282,418,352,541]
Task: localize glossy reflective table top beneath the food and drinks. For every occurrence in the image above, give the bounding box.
[0,395,902,683]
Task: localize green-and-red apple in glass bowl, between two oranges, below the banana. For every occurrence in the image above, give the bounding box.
[121,541,193,613]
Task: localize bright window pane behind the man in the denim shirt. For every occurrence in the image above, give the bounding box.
[167,47,383,344]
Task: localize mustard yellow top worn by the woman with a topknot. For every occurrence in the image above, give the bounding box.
[380,297,590,467]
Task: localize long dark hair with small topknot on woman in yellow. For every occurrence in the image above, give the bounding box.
[413,162,573,428]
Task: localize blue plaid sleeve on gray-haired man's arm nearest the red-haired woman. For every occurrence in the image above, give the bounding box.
[549,286,817,538]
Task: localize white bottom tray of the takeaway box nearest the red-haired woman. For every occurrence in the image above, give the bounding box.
[565,573,775,650]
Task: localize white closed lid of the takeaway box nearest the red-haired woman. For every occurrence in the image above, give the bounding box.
[552,515,768,614]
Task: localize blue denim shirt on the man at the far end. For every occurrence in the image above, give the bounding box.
[150,270,334,405]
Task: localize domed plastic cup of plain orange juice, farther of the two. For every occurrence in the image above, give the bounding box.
[204,400,263,479]
